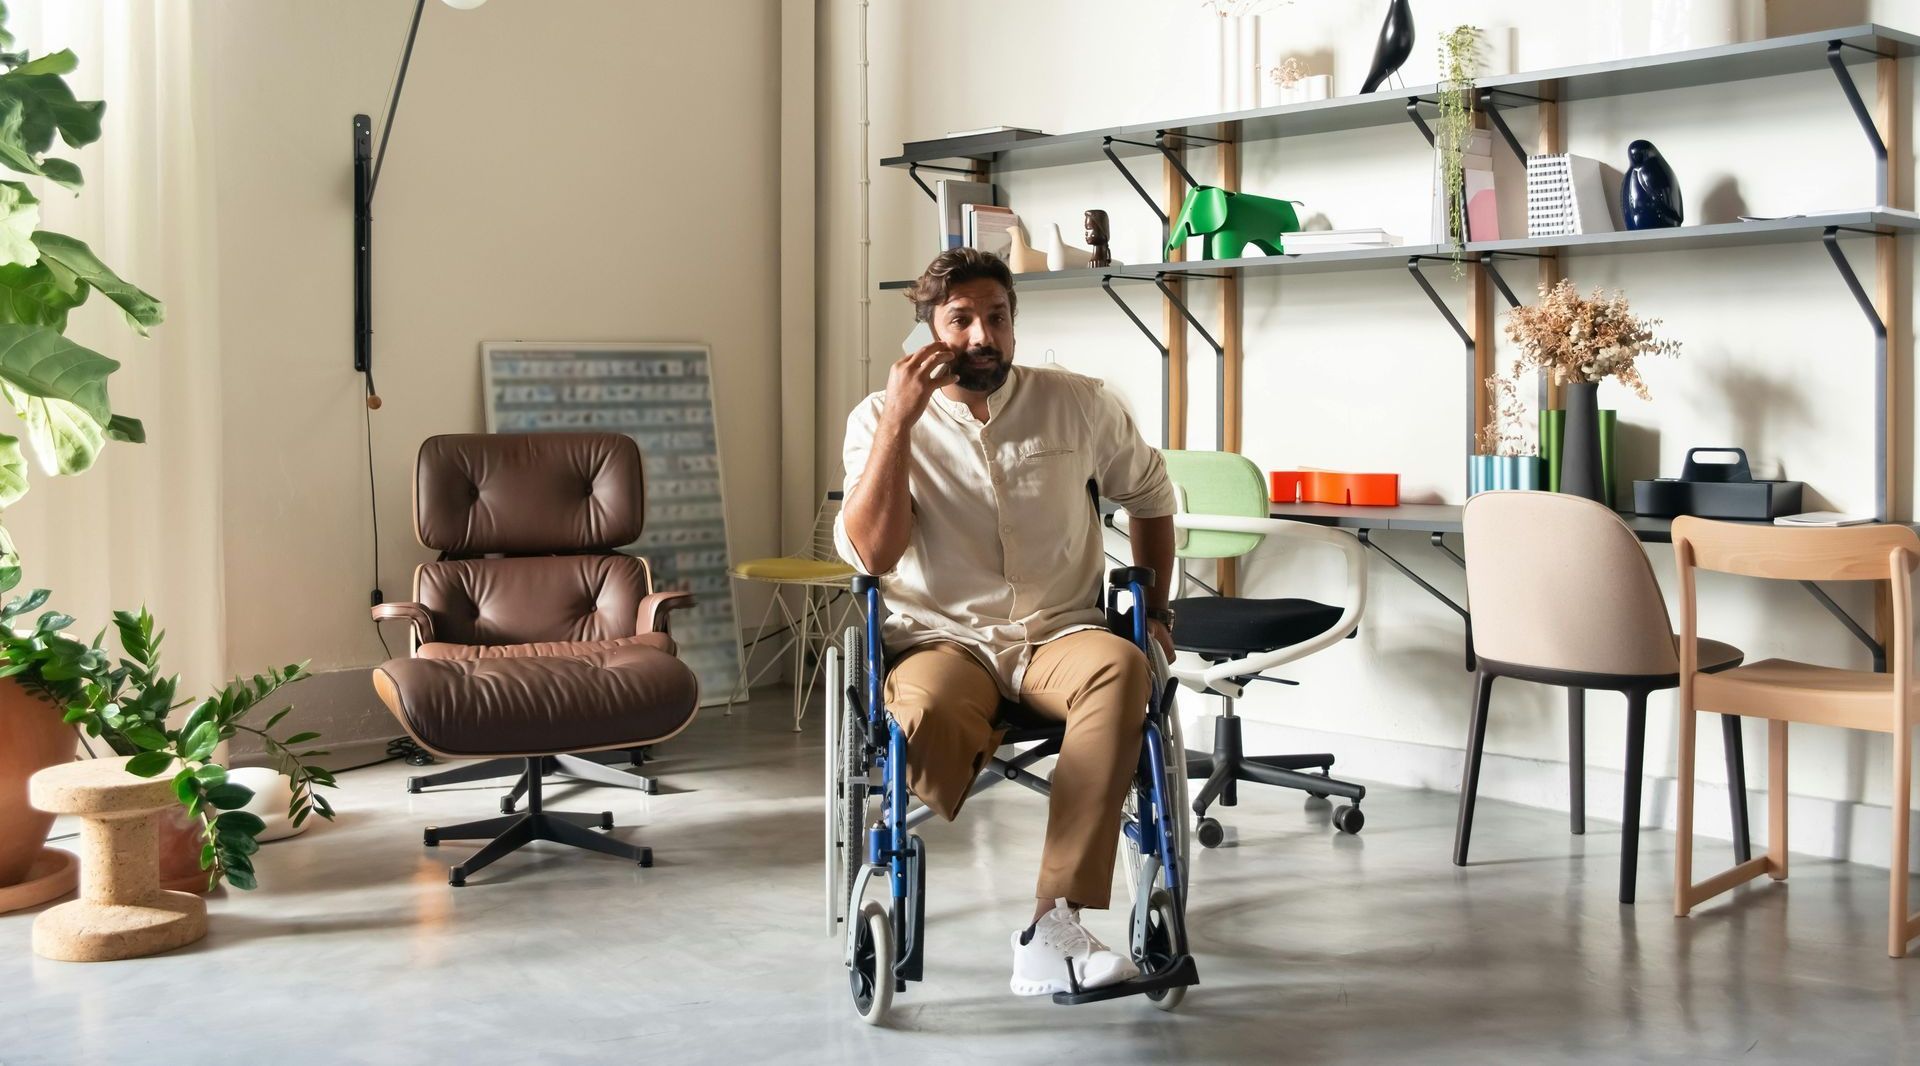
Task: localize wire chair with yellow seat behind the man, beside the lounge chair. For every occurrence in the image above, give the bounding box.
[726,492,852,732]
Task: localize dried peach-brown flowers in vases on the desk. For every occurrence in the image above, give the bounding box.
[1478,279,1680,455]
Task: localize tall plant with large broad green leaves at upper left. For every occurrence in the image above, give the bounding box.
[0,4,165,565]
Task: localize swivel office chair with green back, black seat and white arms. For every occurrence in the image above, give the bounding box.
[1164,451,1367,847]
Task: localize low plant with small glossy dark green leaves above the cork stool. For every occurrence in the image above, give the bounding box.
[0,567,334,889]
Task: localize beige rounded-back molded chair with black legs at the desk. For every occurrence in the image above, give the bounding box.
[1453,492,1747,903]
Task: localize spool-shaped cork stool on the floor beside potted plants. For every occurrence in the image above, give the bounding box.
[27,759,207,962]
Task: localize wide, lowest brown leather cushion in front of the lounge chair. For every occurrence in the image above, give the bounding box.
[374,645,699,757]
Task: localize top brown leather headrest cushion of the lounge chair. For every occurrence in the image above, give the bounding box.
[413,432,647,555]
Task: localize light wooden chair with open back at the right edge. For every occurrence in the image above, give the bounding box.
[1674,519,1920,958]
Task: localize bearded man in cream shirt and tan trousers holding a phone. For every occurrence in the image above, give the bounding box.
[835,248,1175,995]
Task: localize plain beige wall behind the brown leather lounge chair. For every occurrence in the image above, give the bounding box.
[198,0,780,745]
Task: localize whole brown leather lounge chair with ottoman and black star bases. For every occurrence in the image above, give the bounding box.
[372,434,699,885]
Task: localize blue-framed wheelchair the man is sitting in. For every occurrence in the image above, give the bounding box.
[826,567,1200,1024]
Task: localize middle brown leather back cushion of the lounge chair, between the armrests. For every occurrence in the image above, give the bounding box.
[413,553,653,643]
